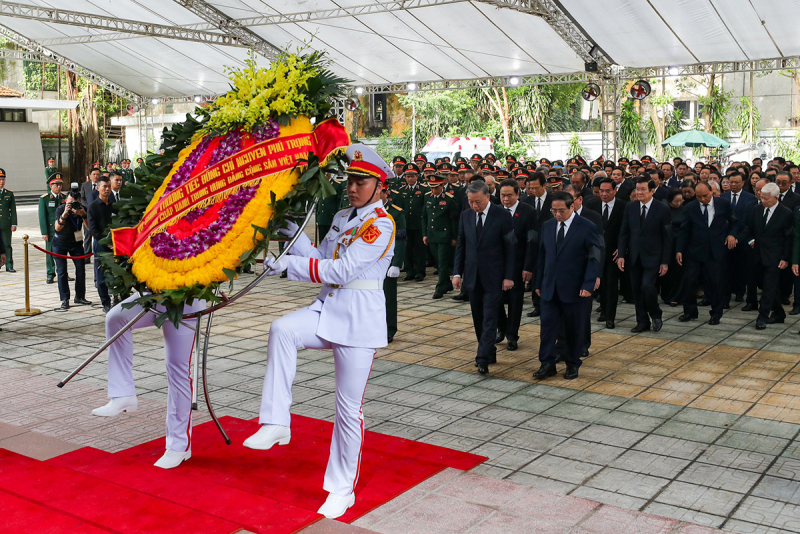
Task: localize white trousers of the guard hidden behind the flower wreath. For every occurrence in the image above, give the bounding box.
[106,295,206,451]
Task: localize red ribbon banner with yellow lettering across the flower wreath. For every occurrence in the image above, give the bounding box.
[111,119,350,256]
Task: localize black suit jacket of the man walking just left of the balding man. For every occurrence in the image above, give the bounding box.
[619,199,672,268]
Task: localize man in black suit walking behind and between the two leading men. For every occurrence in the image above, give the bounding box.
[495,179,538,350]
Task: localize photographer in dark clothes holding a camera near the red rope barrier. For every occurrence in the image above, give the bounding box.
[53,190,91,310]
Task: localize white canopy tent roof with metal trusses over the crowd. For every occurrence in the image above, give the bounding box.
[0,0,800,157]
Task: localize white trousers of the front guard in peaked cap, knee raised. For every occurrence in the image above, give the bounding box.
[259,308,375,496]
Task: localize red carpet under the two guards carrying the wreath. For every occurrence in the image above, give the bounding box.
[0,416,485,534]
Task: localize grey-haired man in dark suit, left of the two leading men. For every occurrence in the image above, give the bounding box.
[453,181,514,375]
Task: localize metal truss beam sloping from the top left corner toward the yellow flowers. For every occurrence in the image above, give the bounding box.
[0,1,248,46]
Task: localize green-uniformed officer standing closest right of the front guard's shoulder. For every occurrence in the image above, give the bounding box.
[400,163,428,281]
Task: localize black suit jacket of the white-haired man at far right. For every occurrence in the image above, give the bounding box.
[737,203,794,268]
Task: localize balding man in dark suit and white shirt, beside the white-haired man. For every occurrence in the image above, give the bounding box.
[675,182,736,325]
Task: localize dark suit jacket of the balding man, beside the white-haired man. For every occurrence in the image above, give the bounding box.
[676,197,736,262]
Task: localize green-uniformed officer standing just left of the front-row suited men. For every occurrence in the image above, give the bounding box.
[422,173,461,299]
